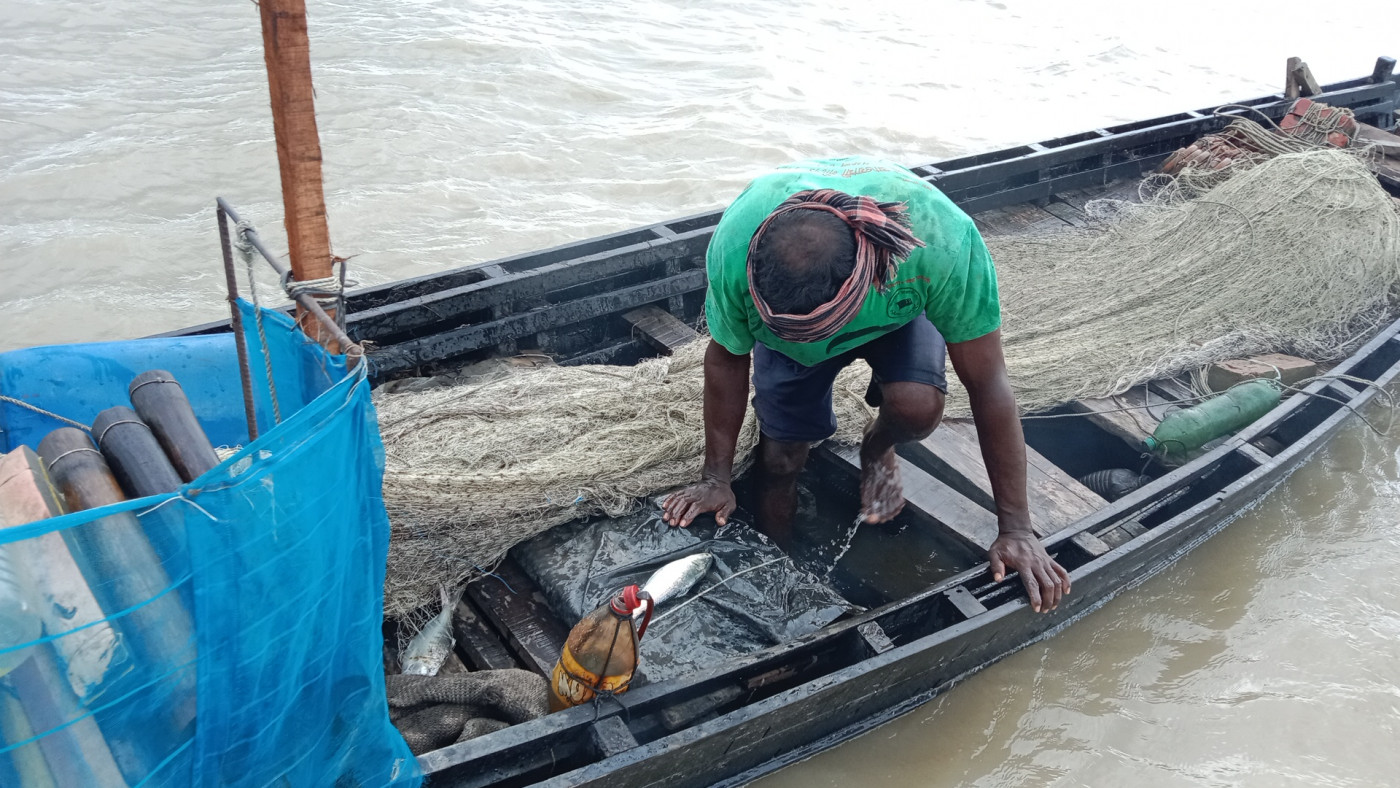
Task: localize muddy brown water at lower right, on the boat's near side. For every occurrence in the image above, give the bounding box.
[762,418,1400,788]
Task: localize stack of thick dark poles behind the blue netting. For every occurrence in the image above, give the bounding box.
[0,370,218,785]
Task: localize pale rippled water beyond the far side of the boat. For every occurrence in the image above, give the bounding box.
[8,0,1372,349]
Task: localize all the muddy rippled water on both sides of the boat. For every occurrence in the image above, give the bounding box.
[0,0,1400,785]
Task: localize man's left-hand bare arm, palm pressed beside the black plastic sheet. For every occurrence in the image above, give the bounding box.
[661,339,749,528]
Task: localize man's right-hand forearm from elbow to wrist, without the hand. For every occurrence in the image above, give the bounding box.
[969,378,1030,533]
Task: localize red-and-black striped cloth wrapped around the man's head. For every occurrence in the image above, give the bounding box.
[748,189,924,342]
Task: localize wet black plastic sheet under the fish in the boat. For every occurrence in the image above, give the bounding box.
[511,511,860,682]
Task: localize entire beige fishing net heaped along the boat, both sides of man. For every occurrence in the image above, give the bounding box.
[375,144,1400,616]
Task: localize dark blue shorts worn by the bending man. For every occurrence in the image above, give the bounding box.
[753,315,948,442]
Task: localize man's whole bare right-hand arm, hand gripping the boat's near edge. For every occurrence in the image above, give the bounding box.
[948,329,1070,613]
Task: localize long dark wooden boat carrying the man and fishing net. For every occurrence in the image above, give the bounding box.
[176,59,1400,787]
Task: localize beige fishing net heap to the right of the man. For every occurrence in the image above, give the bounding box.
[985,150,1400,416]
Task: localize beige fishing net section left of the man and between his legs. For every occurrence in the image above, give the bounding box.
[375,342,871,616]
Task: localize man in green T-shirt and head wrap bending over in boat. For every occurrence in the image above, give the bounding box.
[664,157,1070,612]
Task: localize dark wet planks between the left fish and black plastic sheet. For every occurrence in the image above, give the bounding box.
[466,560,568,677]
